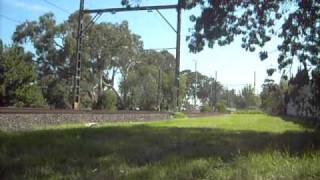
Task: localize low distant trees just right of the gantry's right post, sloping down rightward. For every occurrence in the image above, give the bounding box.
[181,70,260,112]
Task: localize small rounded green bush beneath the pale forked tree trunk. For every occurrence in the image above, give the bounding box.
[94,90,117,111]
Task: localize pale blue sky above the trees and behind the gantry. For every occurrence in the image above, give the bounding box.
[0,0,280,93]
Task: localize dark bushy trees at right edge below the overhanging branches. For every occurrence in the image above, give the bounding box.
[261,67,320,119]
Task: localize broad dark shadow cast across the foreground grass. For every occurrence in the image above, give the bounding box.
[0,125,320,179]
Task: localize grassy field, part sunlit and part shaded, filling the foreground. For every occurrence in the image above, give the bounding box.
[0,114,320,180]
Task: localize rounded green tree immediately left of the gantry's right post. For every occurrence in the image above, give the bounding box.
[120,51,178,110]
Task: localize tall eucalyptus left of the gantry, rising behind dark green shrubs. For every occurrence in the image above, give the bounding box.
[12,13,72,107]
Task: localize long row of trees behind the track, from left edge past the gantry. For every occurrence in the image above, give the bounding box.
[0,13,258,111]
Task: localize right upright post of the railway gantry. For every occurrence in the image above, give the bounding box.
[175,3,181,111]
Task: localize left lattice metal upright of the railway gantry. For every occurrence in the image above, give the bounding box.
[73,0,84,110]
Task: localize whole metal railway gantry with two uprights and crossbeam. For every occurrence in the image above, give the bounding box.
[73,0,181,110]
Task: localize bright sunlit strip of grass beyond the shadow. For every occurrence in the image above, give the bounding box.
[149,114,308,133]
